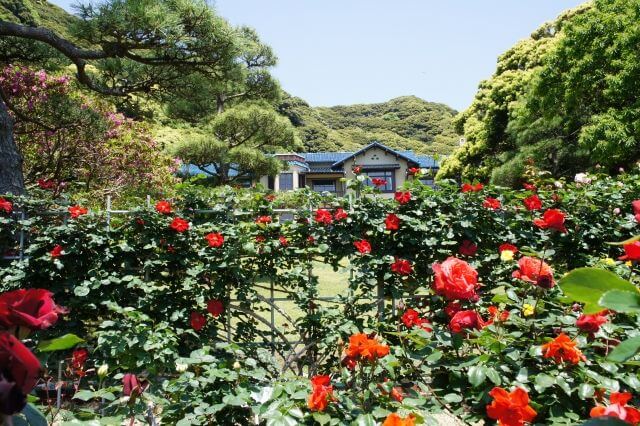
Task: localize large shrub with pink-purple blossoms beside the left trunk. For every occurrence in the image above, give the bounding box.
[0,66,175,199]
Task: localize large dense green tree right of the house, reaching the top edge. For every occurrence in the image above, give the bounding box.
[441,0,640,185]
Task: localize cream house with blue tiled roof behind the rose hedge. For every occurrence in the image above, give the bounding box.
[186,142,439,196]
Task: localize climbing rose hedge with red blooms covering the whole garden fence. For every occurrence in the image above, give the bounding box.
[0,169,640,425]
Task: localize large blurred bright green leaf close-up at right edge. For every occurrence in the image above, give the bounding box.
[558,268,638,314]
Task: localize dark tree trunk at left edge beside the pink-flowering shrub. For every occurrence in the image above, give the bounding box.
[0,99,24,195]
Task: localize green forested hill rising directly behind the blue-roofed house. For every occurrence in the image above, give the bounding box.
[279,96,460,155]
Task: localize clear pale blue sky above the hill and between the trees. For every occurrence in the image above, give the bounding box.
[47,0,582,110]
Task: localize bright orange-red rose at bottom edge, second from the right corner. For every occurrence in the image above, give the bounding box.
[487,387,538,426]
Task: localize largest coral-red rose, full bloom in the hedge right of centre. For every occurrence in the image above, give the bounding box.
[431,257,480,300]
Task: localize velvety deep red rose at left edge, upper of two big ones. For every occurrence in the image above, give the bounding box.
[0,288,66,330]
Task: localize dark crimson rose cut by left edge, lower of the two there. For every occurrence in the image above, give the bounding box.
[0,331,41,415]
